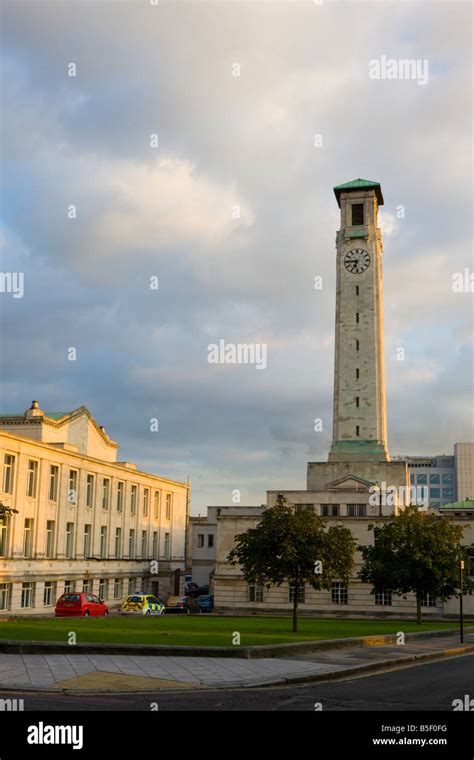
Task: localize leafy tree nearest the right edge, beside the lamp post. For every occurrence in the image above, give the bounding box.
[358,506,473,623]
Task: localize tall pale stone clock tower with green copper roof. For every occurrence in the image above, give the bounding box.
[329,179,390,462]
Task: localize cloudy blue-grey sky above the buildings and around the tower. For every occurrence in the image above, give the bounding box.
[0,0,474,514]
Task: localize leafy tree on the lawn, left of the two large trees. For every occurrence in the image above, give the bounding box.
[228,494,355,631]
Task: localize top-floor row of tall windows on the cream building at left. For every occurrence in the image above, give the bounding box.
[2,454,173,520]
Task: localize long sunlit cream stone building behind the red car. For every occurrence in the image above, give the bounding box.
[0,401,189,614]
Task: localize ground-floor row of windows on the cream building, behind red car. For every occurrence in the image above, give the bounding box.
[0,578,145,610]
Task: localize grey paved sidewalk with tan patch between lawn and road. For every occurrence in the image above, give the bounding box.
[0,634,474,692]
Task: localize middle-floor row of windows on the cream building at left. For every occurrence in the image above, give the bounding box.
[0,518,170,559]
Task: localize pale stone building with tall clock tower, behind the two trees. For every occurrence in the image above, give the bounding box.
[210,179,474,618]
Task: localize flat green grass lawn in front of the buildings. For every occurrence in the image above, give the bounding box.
[0,615,464,646]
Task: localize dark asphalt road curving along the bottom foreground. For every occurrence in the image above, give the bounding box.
[0,655,474,712]
